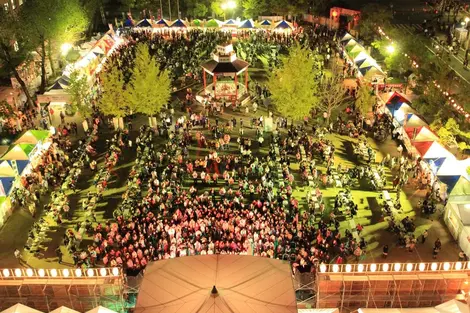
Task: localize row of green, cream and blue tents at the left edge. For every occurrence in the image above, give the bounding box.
[0,130,51,228]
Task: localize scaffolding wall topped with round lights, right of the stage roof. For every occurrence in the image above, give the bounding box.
[314,262,470,312]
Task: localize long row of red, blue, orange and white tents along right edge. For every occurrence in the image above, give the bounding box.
[382,92,470,251]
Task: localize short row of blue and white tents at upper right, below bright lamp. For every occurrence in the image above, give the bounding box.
[340,33,385,80]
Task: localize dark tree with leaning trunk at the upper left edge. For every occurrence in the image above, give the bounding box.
[0,10,34,106]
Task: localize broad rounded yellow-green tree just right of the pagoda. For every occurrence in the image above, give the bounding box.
[268,44,319,120]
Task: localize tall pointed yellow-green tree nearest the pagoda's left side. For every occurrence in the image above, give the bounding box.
[127,44,171,116]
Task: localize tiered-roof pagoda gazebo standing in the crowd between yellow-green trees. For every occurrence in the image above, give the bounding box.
[201,43,249,102]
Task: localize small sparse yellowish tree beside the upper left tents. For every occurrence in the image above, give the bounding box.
[67,71,93,118]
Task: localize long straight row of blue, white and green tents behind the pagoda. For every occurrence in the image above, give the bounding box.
[129,19,294,30]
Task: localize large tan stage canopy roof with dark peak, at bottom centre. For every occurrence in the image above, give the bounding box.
[135,255,297,313]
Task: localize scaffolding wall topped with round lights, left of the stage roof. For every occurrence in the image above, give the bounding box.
[0,268,126,312]
